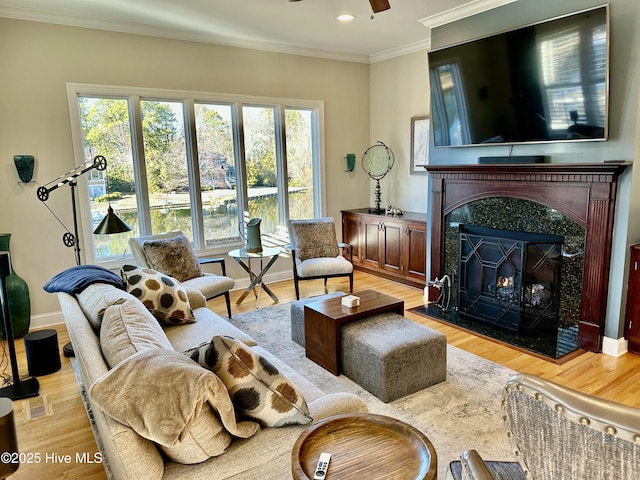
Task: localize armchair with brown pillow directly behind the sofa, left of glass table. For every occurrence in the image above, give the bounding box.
[129,230,235,318]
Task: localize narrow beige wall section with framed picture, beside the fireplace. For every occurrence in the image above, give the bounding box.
[370,51,430,215]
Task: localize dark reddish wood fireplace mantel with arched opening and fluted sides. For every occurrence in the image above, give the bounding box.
[425,162,630,352]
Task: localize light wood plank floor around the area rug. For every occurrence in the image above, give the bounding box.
[3,272,640,480]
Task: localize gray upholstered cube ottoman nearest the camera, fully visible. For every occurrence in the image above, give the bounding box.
[342,312,447,402]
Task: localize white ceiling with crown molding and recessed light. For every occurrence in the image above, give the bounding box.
[0,0,514,62]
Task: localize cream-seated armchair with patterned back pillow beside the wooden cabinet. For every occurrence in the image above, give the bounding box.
[289,217,353,300]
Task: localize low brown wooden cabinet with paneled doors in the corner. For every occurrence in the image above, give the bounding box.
[342,208,427,288]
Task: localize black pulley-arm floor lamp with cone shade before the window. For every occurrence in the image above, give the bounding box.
[36,155,132,357]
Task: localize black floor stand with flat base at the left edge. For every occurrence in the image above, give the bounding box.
[0,252,40,400]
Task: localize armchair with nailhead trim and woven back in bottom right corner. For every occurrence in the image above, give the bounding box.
[447,374,640,480]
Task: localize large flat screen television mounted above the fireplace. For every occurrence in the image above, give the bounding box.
[428,5,609,147]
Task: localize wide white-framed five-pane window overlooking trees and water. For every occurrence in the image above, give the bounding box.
[68,84,322,262]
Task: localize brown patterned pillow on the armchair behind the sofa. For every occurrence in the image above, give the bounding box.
[142,235,203,282]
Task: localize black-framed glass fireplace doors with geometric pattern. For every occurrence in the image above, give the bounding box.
[457,225,564,335]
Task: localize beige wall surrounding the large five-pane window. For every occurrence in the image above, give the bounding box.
[0,18,369,318]
